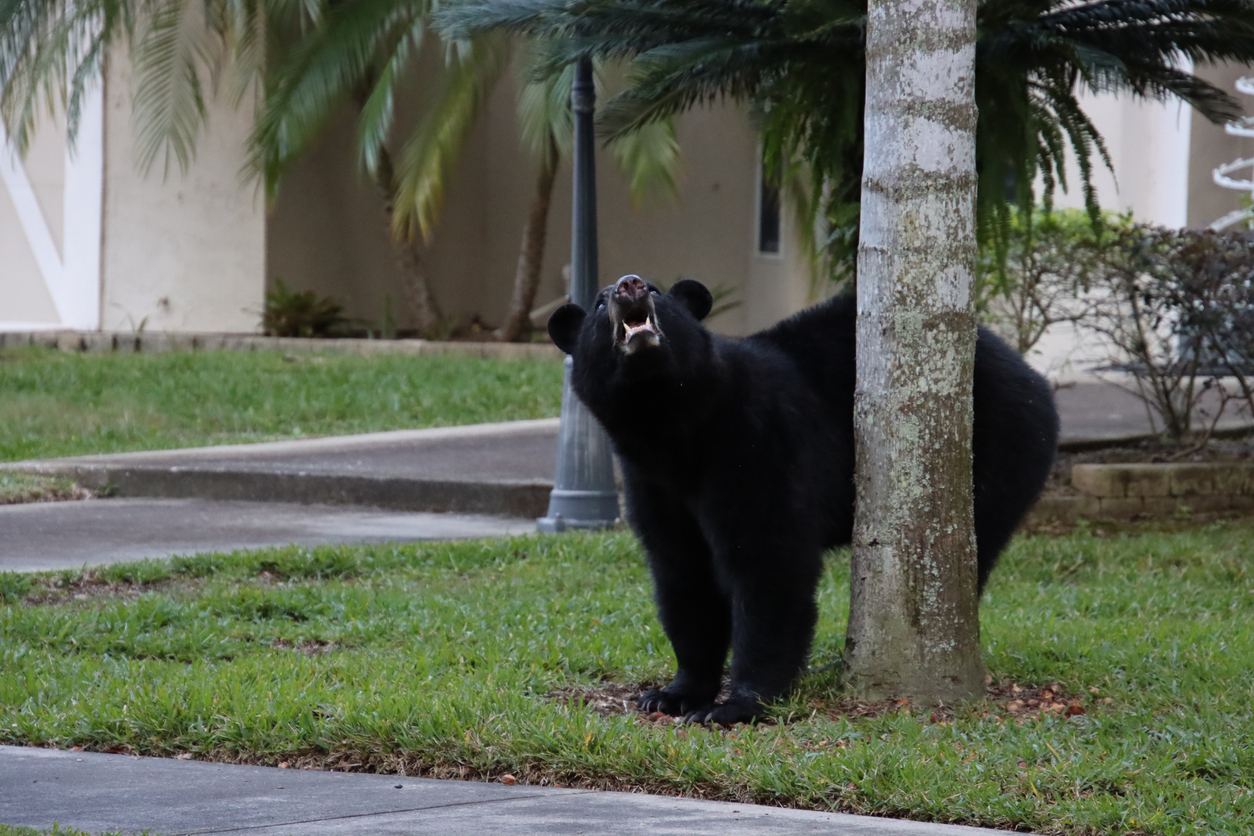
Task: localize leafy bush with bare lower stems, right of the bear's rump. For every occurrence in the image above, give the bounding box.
[977,209,1254,441]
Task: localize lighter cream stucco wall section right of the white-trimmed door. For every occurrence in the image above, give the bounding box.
[100,55,266,331]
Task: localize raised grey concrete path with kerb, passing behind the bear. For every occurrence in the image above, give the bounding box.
[7,384,1243,519]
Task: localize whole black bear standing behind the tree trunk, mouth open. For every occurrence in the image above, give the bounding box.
[548,276,1058,723]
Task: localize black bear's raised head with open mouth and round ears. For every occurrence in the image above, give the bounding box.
[548,276,714,420]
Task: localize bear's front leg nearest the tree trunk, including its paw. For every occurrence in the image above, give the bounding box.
[688,545,823,726]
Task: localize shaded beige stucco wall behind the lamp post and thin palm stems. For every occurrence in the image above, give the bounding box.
[266,59,808,333]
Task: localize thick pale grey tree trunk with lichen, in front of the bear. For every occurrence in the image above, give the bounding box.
[845,0,983,702]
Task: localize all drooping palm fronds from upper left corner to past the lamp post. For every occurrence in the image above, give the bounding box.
[0,0,678,340]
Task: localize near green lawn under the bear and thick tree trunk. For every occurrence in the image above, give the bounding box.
[0,523,1254,833]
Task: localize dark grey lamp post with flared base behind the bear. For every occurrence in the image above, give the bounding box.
[537,58,618,531]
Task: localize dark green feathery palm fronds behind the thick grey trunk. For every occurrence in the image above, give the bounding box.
[436,0,1254,278]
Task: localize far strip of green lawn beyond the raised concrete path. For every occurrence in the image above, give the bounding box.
[0,348,562,461]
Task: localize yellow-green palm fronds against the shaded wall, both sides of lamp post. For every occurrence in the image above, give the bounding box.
[252,17,678,341]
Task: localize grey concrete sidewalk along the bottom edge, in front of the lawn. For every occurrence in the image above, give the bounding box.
[0,746,1008,836]
